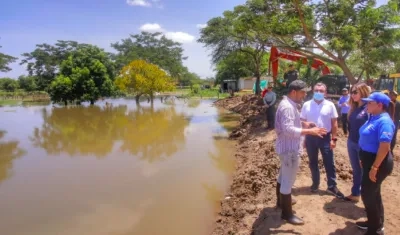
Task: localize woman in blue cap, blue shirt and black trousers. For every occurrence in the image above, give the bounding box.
[356,92,394,235]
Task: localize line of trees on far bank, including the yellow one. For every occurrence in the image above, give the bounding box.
[0,32,211,104]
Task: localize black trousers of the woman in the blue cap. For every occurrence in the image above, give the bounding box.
[360,150,398,234]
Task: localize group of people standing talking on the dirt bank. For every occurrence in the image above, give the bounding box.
[272,80,400,235]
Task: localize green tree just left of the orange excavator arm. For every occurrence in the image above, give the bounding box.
[198,1,271,94]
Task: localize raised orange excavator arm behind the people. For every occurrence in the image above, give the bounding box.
[269,46,331,83]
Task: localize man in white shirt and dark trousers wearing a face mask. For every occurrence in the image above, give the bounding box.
[301,83,344,198]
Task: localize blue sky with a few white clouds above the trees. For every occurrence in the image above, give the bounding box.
[0,0,387,77]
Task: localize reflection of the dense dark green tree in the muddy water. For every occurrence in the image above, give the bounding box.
[31,105,127,158]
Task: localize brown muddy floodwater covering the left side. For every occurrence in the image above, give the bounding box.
[0,99,237,235]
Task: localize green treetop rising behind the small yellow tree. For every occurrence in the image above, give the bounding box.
[111,32,187,78]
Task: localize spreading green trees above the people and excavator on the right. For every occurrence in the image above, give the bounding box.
[198,0,400,93]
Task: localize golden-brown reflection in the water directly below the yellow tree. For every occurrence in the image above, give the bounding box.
[121,106,189,162]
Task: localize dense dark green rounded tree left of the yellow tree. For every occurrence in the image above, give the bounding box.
[48,44,115,105]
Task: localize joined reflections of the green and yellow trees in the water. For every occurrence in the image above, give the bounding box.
[31,105,189,162]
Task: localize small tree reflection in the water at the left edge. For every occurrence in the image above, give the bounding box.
[0,130,25,183]
